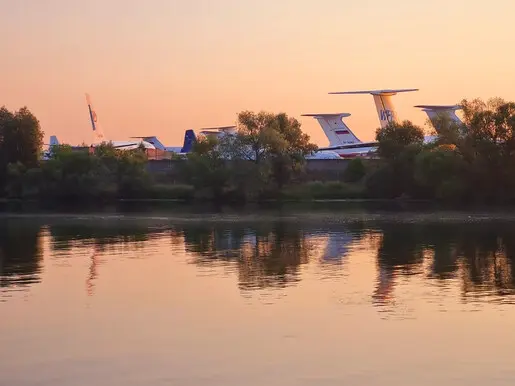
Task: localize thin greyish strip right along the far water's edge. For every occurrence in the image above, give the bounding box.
[0,209,515,227]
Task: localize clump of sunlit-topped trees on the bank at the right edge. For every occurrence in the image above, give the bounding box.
[366,98,515,204]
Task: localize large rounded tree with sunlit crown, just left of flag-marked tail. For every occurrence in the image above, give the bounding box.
[180,111,316,199]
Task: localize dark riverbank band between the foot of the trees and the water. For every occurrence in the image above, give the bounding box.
[5,200,515,227]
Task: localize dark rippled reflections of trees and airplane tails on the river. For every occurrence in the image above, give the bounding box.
[0,220,515,307]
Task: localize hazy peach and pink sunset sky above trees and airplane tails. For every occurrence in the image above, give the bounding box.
[0,0,515,146]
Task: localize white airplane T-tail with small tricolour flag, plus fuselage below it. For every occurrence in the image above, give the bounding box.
[302,113,377,158]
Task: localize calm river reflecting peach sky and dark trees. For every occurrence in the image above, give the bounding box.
[0,208,515,385]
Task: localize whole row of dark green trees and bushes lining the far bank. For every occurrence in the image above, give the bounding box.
[0,98,515,204]
